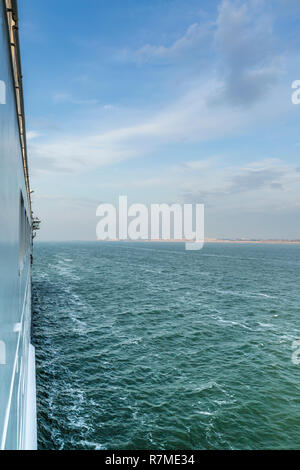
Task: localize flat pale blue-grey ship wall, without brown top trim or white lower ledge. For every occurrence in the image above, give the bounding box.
[0,0,31,449]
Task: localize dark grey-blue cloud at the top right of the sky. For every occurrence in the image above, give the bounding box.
[214,0,282,106]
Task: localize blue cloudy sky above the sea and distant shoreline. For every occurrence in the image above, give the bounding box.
[19,0,300,240]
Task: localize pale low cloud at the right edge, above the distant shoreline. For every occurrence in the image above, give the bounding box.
[182,159,300,210]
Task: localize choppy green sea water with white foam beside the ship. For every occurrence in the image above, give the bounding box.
[33,243,300,449]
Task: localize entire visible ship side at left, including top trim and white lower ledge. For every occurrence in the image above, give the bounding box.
[0,0,37,450]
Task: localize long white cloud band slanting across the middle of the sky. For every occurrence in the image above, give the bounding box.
[30,72,290,175]
